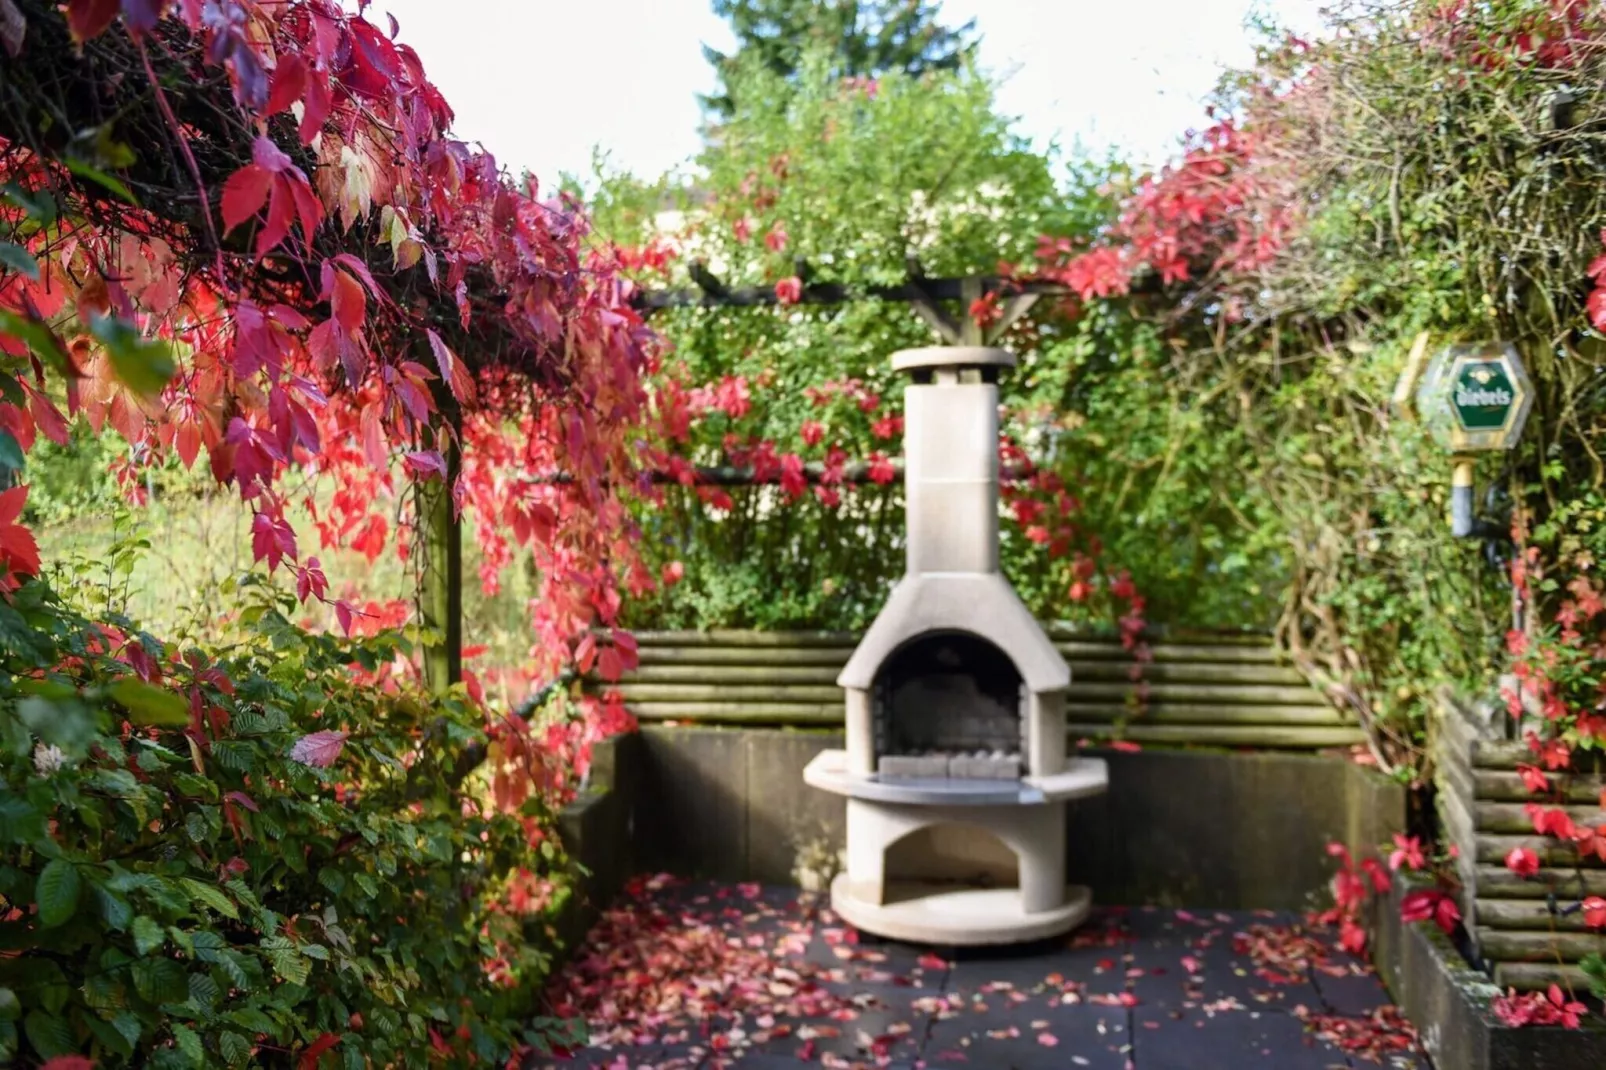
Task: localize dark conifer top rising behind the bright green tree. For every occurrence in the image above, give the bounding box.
[702,0,975,119]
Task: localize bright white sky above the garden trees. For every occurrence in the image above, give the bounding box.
[369,0,1325,186]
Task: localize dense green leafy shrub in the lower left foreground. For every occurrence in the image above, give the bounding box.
[0,580,578,1067]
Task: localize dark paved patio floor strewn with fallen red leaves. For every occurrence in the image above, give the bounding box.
[527,877,1429,1070]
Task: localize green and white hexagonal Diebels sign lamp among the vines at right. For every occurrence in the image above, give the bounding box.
[1416,342,1534,453]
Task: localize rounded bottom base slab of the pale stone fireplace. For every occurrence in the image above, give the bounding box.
[830,874,1092,946]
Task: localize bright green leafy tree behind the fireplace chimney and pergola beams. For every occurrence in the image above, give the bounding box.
[593,50,1175,627]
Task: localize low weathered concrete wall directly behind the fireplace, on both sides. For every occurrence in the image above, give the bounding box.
[622,726,1405,908]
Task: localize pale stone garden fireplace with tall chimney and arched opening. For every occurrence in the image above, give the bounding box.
[803,347,1107,945]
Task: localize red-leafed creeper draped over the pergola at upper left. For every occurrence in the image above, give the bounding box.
[0,0,654,677]
